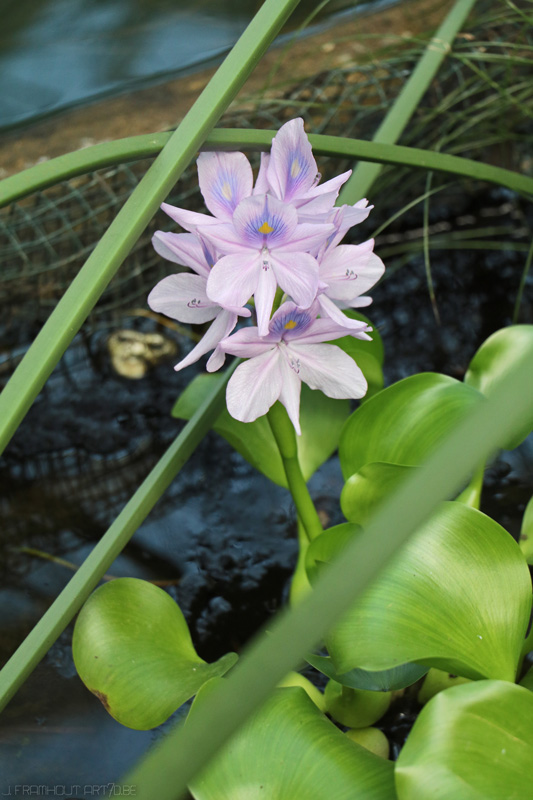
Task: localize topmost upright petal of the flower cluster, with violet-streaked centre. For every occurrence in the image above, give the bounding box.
[267,117,317,203]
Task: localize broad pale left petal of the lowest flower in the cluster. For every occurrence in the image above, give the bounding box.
[226,347,282,422]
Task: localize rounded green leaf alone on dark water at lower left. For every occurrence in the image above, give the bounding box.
[72,578,237,730]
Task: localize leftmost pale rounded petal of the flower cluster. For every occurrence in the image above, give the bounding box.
[148,272,220,324]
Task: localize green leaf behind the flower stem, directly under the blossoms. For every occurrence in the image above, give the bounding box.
[172,374,350,488]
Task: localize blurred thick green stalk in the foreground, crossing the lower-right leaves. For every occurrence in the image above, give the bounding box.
[120,334,533,800]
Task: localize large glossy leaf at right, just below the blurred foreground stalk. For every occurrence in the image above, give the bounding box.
[318,502,531,681]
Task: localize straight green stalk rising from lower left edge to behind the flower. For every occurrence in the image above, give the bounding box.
[0,362,238,710]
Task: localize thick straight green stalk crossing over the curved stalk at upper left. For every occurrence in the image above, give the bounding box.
[0,0,299,460]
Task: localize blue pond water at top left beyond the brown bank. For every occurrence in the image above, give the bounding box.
[0,0,391,130]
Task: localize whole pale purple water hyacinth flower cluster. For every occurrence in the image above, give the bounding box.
[148,119,384,433]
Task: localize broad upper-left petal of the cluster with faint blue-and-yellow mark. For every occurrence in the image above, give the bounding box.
[197,152,254,222]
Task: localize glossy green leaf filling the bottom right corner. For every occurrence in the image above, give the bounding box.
[395,681,533,800]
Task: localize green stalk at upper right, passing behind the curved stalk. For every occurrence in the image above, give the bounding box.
[338,0,475,205]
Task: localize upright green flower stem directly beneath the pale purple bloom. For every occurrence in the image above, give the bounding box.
[267,403,324,542]
